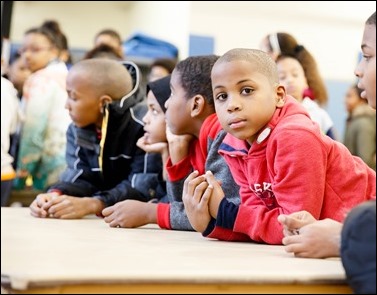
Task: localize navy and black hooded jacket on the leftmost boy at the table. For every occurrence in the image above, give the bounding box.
[50,62,162,206]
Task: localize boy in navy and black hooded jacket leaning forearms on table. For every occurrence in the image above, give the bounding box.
[30,58,162,219]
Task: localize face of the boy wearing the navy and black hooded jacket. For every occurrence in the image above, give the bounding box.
[65,70,102,128]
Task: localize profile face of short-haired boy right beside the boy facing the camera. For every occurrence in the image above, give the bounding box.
[165,70,193,135]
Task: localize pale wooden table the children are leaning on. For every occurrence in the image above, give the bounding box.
[1,208,351,294]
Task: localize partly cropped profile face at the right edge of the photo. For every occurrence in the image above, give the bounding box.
[355,25,376,109]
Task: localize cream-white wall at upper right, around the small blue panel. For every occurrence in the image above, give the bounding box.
[190,1,376,81]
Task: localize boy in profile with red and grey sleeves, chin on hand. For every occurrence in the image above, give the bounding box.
[102,55,239,231]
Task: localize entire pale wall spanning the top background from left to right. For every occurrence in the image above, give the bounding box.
[10,1,376,81]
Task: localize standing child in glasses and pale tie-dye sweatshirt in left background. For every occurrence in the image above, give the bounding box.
[14,22,71,190]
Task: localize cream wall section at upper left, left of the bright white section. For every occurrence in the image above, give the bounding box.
[10,1,134,49]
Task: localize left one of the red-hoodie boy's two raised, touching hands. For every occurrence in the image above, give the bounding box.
[182,171,213,232]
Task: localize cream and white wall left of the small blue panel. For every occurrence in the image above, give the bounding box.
[10,1,190,58]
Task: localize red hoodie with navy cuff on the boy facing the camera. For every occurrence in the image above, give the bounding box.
[203,97,376,244]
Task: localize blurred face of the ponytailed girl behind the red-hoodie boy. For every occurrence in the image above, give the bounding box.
[276,57,309,101]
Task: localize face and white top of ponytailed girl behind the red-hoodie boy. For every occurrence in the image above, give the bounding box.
[276,52,337,139]
